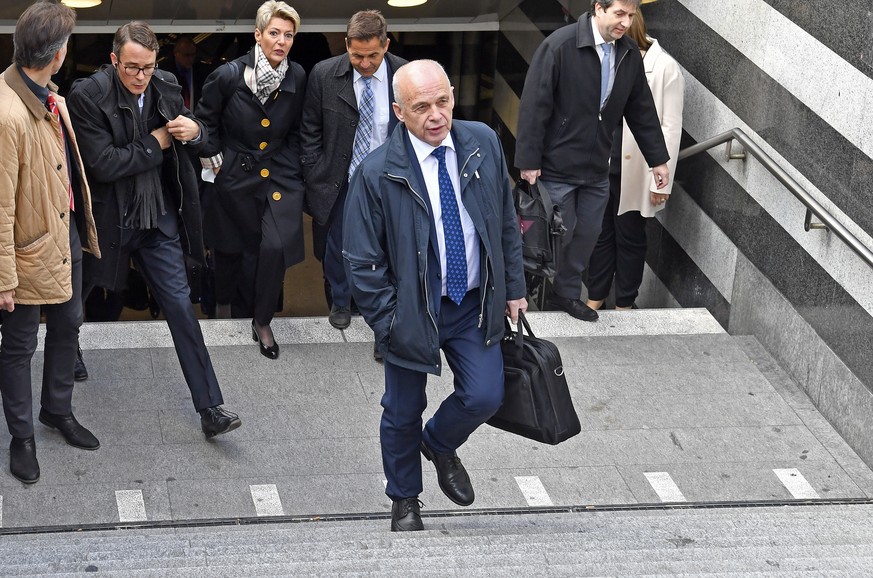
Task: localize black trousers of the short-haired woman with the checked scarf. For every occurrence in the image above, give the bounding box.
[214,204,285,327]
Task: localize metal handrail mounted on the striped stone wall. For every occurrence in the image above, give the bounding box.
[679,128,873,267]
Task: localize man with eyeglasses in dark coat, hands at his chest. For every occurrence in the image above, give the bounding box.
[68,22,240,438]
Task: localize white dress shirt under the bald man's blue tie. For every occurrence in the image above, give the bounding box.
[409,133,479,295]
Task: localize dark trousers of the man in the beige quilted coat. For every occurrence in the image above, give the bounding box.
[0,215,82,438]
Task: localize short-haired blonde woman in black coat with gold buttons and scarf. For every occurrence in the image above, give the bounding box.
[197,0,306,359]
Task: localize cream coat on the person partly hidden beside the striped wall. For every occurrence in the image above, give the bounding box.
[618,40,685,217]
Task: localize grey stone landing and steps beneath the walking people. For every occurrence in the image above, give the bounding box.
[0,310,873,576]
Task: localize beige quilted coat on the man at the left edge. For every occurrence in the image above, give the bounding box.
[0,64,99,305]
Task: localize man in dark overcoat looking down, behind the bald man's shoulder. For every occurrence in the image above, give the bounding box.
[301,10,406,338]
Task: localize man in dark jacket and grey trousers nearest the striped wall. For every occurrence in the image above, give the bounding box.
[515,0,670,321]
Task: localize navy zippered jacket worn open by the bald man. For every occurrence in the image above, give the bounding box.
[343,120,526,375]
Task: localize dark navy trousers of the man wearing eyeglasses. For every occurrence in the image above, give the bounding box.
[122,229,224,411]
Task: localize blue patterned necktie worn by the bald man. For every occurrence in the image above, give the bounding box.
[432,146,467,305]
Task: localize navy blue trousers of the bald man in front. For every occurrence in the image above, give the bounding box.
[379,290,503,500]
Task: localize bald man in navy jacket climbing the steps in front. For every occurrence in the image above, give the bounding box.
[343,60,527,531]
